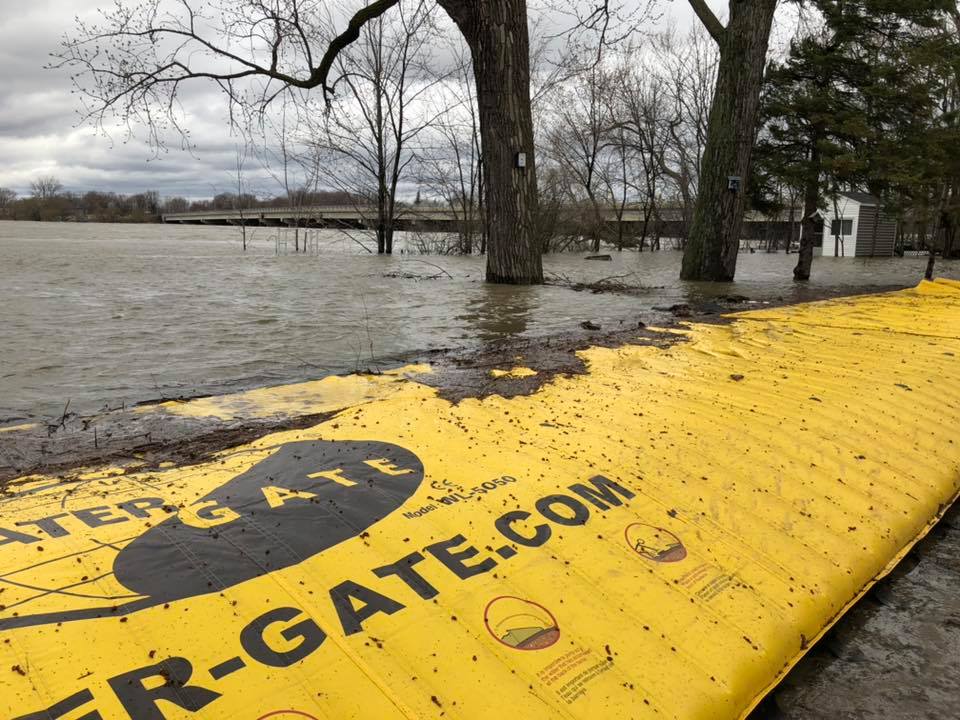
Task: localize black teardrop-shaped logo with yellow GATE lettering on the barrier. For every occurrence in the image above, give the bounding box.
[0,440,424,629]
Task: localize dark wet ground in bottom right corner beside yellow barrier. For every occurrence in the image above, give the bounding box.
[751,505,960,720]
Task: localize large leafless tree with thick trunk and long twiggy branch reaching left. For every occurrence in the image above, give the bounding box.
[57,0,543,283]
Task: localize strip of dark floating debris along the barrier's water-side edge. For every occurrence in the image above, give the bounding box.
[0,287,902,483]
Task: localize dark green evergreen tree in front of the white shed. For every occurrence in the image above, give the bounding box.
[758,0,960,280]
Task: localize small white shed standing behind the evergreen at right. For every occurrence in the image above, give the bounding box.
[814,192,897,257]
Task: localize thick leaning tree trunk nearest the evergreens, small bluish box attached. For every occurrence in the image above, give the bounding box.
[680,0,777,281]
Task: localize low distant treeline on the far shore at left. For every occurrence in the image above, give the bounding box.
[0,178,352,223]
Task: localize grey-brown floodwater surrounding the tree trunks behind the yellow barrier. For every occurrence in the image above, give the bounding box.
[0,222,960,425]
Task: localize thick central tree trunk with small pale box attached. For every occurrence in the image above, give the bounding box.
[440,0,543,284]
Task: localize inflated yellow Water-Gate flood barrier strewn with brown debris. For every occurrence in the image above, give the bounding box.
[0,282,960,720]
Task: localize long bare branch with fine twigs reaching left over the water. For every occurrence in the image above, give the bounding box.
[51,0,408,149]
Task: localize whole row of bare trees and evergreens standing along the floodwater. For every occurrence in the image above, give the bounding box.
[52,0,960,283]
